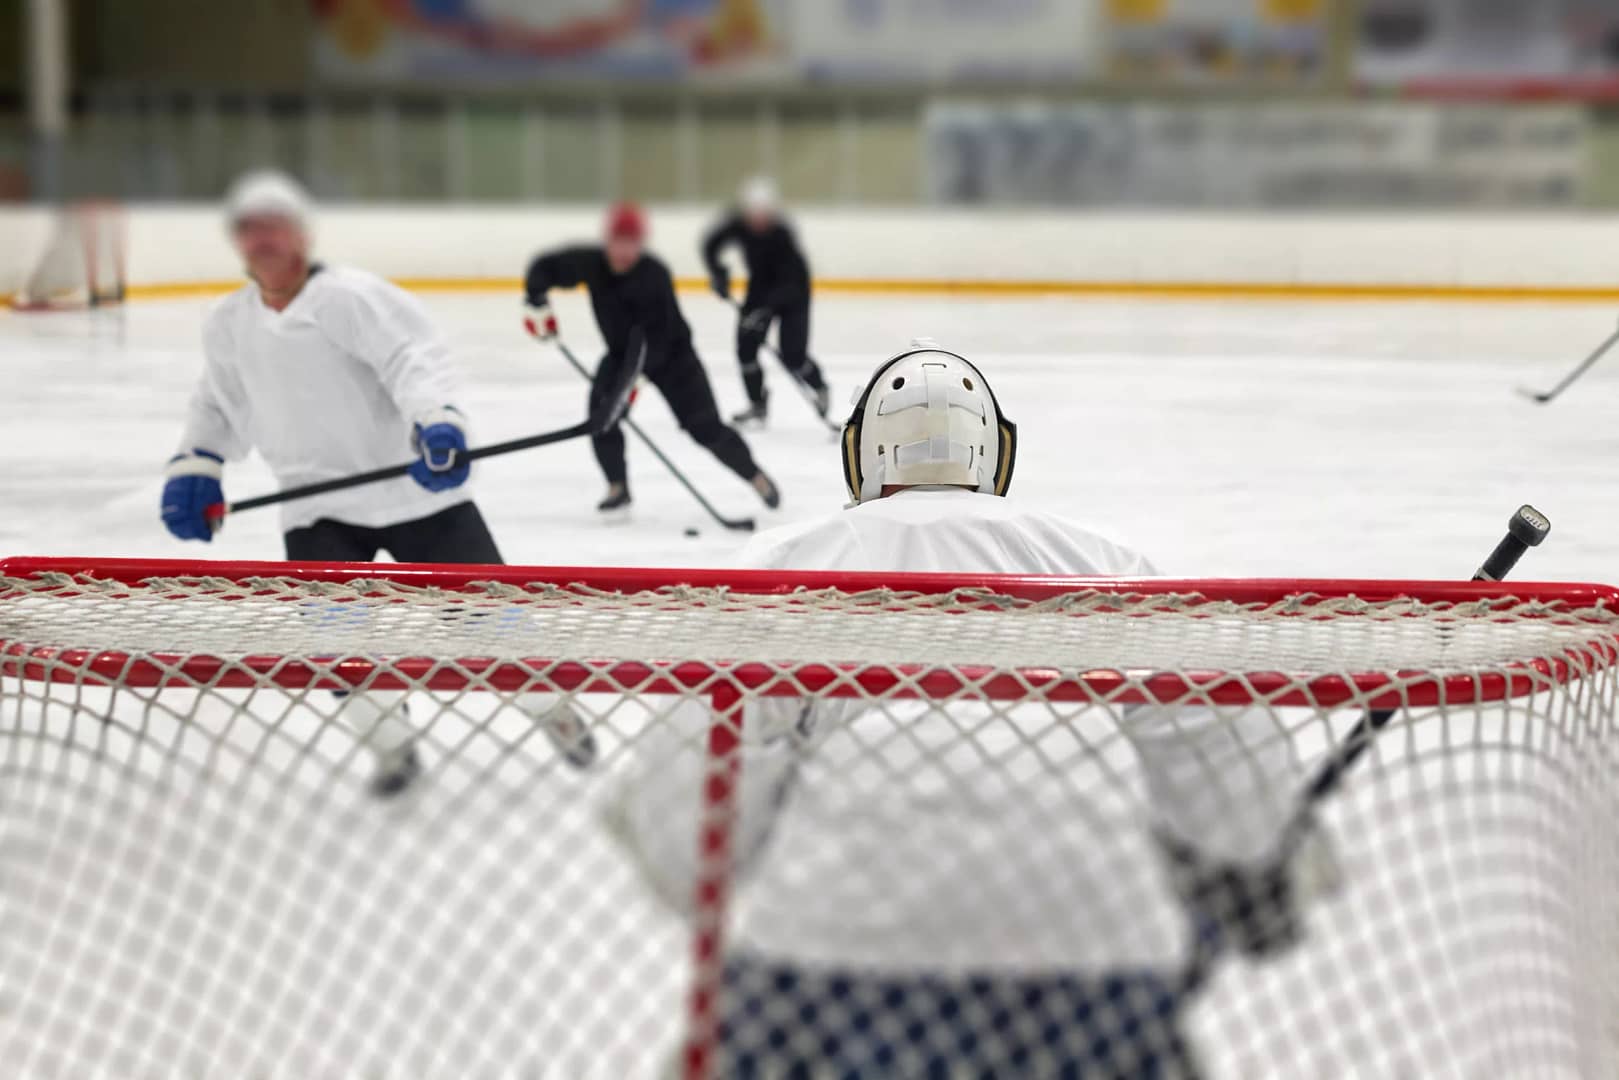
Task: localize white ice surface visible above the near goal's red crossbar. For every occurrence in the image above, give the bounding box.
[9,286,1619,581]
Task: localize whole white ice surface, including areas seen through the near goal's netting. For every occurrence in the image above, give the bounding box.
[0,293,1619,1078]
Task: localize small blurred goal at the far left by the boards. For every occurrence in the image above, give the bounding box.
[11,202,125,311]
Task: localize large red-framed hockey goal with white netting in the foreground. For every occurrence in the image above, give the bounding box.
[0,560,1619,1077]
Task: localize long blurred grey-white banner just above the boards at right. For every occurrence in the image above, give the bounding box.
[926,102,1587,209]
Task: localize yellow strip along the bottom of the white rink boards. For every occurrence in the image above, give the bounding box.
[9,277,1619,304]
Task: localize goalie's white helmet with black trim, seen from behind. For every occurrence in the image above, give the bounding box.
[843,338,1017,502]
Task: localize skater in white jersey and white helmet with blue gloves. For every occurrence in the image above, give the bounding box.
[162,173,594,795]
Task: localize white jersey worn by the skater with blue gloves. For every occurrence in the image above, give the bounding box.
[180,266,471,529]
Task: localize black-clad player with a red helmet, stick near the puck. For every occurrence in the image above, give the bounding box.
[525,202,782,510]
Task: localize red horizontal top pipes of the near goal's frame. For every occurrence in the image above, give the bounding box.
[0,559,1619,709]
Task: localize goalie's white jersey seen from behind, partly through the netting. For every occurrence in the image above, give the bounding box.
[618,489,1300,973]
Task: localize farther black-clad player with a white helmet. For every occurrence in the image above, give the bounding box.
[703,176,831,424]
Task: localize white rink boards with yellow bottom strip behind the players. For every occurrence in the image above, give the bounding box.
[0,206,1619,300]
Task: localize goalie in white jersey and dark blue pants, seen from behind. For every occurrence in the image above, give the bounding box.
[614,342,1324,1077]
